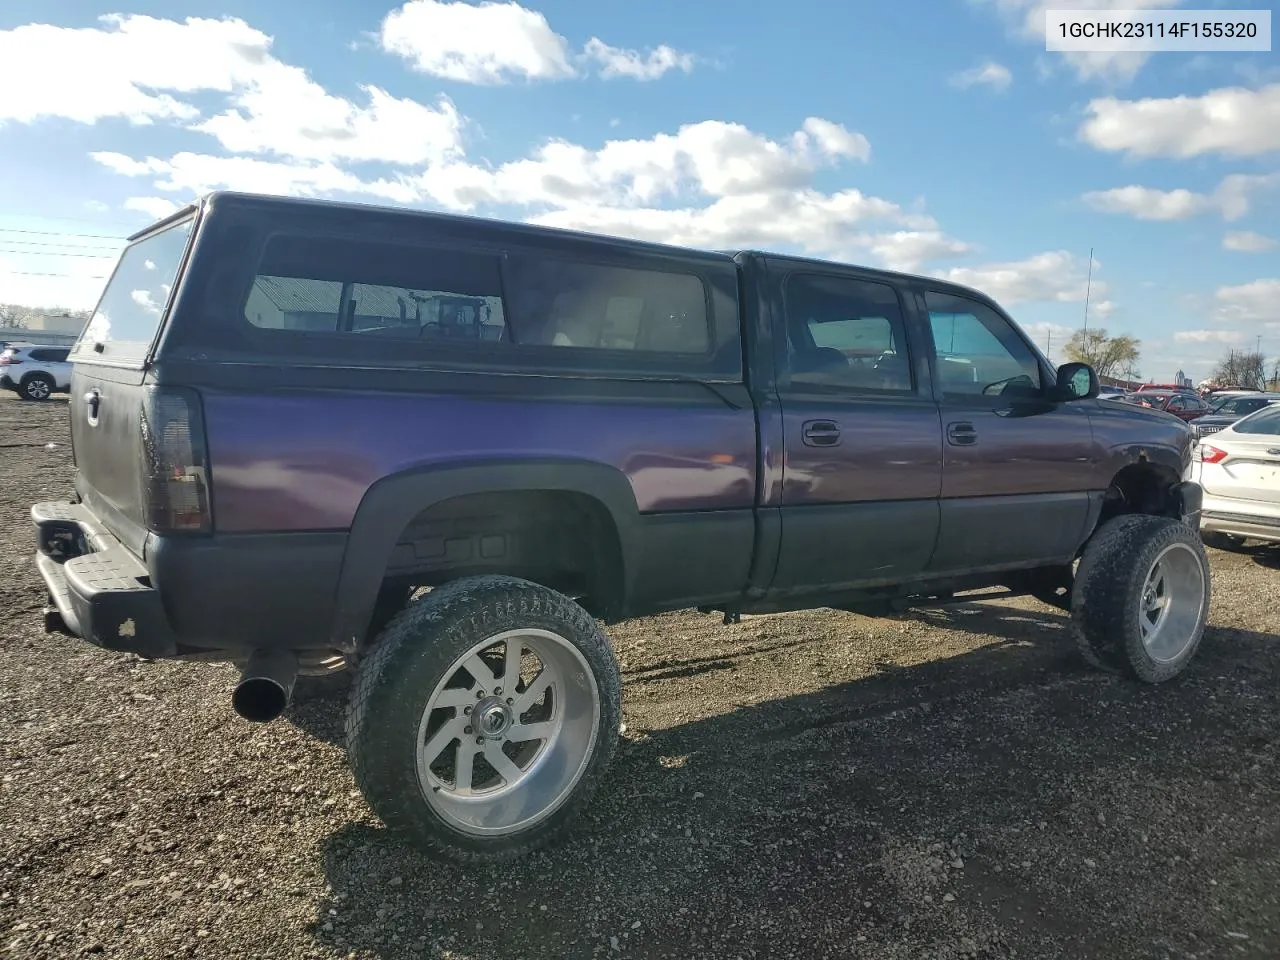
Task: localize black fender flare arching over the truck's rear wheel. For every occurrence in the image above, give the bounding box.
[332,458,640,650]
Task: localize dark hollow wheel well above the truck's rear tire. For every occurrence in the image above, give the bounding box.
[373,490,623,620]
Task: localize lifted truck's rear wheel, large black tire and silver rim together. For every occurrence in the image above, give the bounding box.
[347,576,621,863]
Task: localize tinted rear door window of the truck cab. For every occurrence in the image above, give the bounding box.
[783,274,913,393]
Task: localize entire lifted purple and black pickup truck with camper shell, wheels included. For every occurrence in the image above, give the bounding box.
[32,193,1210,859]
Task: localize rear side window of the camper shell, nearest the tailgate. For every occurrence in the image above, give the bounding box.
[243,237,507,342]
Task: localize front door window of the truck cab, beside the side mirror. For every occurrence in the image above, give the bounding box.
[925,291,1043,397]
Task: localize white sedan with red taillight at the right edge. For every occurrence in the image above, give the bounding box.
[1185,404,1280,545]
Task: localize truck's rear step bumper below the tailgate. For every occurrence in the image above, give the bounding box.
[31,502,178,658]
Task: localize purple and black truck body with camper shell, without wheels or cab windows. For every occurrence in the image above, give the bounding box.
[36,195,1187,670]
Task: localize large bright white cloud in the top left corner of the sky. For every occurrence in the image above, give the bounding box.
[0,15,461,164]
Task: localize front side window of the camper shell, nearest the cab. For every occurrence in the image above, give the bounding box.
[511,257,713,357]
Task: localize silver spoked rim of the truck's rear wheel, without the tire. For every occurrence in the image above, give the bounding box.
[416,630,600,836]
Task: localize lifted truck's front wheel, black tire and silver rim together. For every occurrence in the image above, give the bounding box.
[1071,515,1211,684]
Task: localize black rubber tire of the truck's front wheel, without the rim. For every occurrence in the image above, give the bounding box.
[1071,513,1211,684]
